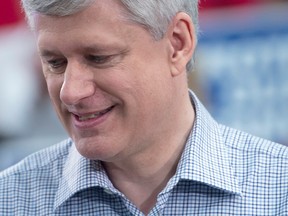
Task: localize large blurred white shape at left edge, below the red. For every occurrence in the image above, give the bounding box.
[0,25,39,136]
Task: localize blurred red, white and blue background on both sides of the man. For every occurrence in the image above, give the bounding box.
[0,0,288,170]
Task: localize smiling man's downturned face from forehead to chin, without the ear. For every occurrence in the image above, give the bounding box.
[35,0,174,161]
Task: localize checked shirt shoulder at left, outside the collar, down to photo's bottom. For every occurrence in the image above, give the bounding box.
[0,140,72,215]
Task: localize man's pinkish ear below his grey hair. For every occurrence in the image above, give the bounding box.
[167,12,196,76]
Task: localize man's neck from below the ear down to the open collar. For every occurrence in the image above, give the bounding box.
[103,87,194,213]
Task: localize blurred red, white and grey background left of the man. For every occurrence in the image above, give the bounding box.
[0,0,67,170]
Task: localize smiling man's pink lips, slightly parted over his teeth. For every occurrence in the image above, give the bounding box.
[71,105,115,130]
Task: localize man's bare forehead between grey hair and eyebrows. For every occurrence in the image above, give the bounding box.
[35,0,154,55]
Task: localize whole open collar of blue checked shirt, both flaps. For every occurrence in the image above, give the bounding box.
[54,91,241,210]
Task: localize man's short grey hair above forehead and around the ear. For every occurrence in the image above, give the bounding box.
[22,0,199,71]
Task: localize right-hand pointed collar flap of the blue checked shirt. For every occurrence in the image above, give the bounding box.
[175,91,241,196]
